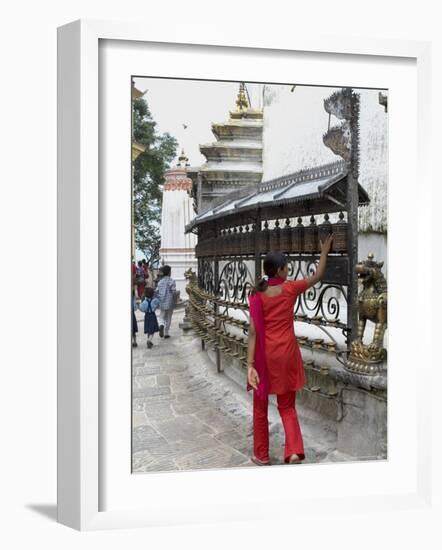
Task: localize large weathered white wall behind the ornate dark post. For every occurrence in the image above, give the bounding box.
[263,85,388,275]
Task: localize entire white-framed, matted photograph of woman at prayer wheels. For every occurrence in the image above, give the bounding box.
[58,21,432,530]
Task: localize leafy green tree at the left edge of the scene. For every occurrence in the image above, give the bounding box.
[132,97,178,262]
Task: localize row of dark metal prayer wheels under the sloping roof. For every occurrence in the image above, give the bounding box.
[195,212,348,257]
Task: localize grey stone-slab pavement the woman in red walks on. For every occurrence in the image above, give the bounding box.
[132,310,351,473]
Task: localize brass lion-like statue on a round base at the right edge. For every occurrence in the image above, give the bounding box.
[346,253,388,374]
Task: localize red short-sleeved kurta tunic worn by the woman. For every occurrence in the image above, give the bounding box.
[261,279,308,394]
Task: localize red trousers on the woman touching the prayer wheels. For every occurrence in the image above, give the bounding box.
[253,391,305,462]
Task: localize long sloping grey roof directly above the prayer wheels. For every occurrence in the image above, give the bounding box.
[186,161,370,233]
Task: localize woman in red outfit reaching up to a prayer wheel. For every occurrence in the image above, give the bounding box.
[247,234,333,466]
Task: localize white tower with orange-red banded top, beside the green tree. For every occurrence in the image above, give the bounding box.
[160,167,197,299]
